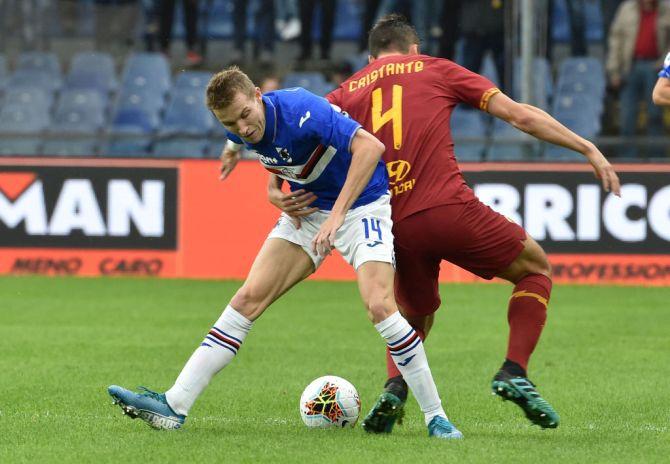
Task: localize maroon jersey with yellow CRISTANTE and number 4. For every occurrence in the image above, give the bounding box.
[326,55,500,221]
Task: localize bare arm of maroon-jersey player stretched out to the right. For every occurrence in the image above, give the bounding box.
[488,93,620,196]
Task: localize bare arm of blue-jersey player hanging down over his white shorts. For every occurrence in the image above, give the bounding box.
[312,128,386,256]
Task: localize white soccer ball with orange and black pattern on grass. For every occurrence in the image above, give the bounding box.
[300,375,361,428]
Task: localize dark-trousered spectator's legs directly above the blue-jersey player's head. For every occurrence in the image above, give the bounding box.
[231,0,275,63]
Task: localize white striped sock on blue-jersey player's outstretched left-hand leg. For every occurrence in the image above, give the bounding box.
[165,305,251,415]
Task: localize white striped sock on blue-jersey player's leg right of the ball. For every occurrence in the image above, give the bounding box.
[375,312,447,425]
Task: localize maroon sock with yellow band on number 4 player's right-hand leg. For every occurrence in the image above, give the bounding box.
[507,274,551,370]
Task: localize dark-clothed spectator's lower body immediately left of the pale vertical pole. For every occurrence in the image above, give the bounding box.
[460,0,505,88]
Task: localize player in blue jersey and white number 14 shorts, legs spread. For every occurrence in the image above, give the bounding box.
[109,67,462,438]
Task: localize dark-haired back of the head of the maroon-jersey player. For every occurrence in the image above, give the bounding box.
[368,13,420,58]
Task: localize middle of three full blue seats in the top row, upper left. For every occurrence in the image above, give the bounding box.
[66,52,119,94]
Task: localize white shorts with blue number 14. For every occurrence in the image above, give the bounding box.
[268,195,395,269]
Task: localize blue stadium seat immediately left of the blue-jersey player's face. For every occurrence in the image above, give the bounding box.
[160,89,214,136]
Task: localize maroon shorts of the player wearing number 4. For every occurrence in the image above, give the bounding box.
[393,200,526,315]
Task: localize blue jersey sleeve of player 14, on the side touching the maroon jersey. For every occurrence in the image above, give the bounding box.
[300,91,361,151]
